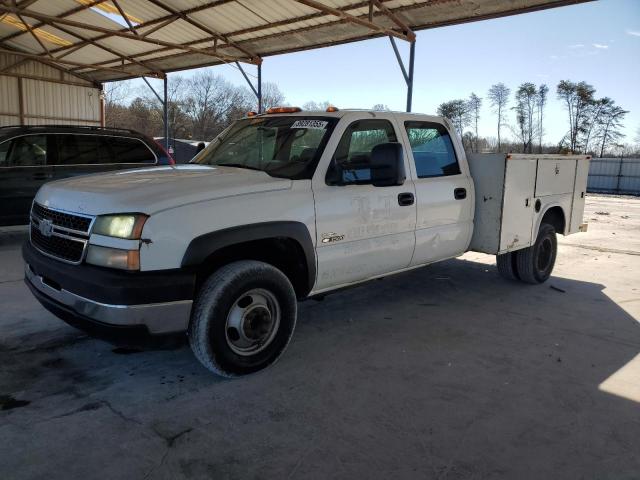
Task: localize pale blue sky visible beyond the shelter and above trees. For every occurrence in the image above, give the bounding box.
[130,0,640,143]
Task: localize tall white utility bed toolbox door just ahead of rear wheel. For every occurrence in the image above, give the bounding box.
[499,158,537,252]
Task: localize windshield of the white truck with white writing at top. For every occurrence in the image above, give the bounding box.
[191,116,337,179]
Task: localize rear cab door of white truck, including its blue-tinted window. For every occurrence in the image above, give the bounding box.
[403,117,474,266]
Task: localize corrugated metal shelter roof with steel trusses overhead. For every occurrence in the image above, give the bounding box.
[0,0,590,82]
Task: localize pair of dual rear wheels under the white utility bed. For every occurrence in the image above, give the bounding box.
[496,223,558,284]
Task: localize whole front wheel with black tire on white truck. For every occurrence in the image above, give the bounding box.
[188,260,297,377]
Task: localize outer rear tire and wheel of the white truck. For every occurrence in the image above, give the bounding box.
[514,223,558,284]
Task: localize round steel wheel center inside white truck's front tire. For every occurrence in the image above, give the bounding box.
[225,288,280,356]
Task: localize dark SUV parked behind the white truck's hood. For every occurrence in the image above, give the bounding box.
[0,125,174,226]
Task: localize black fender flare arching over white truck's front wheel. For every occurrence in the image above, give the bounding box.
[182,221,316,291]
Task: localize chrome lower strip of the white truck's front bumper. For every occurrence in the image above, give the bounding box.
[25,265,193,334]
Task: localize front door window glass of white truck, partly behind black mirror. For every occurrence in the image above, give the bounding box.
[326,119,398,185]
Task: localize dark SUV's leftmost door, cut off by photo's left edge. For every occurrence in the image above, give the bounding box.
[0,135,53,225]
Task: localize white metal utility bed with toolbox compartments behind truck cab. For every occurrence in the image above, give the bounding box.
[467,154,590,254]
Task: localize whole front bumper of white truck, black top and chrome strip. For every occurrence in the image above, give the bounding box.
[23,242,195,335]
